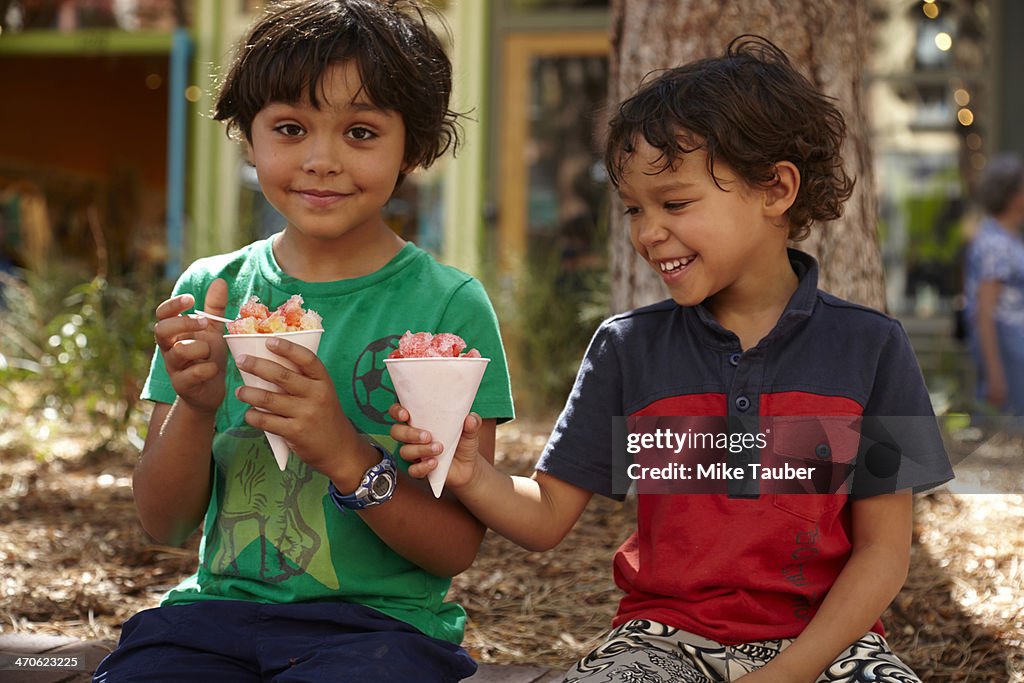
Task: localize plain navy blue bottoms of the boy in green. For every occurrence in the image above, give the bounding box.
[93,600,476,683]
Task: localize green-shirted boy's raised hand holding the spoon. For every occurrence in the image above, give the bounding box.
[153,279,227,414]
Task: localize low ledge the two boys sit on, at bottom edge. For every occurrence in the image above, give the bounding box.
[0,633,562,683]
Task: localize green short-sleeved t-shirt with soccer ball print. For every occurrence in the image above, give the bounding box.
[142,240,513,643]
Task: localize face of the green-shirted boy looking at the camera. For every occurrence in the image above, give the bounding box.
[249,61,406,245]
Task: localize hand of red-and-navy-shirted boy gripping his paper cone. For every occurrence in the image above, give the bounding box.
[388,403,483,488]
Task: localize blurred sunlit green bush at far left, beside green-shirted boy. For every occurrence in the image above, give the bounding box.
[0,269,162,454]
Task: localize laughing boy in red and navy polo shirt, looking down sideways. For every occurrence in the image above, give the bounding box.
[391,37,951,683]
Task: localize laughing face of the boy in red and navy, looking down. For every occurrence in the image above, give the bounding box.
[618,137,799,306]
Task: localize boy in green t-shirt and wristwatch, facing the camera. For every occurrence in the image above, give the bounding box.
[96,0,512,681]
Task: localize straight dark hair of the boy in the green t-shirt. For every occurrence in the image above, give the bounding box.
[213,0,463,179]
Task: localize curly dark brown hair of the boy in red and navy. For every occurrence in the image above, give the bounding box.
[604,34,854,240]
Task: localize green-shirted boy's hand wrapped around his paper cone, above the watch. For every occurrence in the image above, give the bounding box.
[234,339,353,472]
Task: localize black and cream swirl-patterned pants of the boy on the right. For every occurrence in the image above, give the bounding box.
[564,620,922,683]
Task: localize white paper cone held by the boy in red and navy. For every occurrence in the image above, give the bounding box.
[384,357,490,498]
